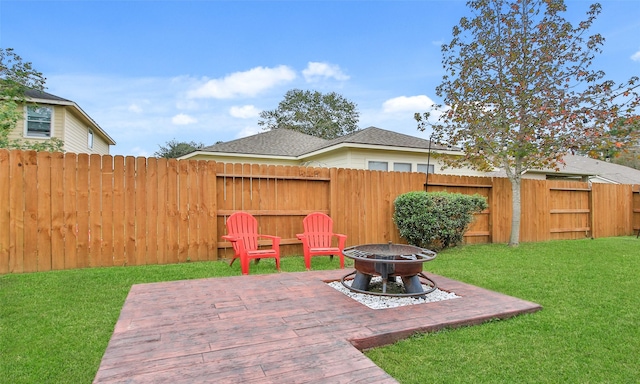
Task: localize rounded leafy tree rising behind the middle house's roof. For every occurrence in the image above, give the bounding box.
[258,89,359,139]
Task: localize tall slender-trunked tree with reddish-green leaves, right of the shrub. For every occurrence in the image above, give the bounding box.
[416,0,640,245]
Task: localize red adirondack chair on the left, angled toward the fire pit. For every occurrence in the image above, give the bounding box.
[222,212,280,275]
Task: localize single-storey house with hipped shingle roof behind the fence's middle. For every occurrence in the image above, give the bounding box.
[180,127,482,176]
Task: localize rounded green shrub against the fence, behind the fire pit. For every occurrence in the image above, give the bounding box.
[393,191,487,250]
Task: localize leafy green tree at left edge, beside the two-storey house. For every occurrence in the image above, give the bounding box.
[0,48,64,151]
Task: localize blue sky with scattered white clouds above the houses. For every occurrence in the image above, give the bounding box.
[0,0,640,156]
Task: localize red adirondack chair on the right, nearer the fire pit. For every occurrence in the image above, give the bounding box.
[296,212,347,270]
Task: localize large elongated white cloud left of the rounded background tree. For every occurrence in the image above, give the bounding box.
[188,65,296,99]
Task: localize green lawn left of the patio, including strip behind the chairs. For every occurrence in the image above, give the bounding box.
[0,257,348,384]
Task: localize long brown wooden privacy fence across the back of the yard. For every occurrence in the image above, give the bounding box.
[0,150,640,274]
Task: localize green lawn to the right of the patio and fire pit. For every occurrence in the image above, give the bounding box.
[366,237,640,383]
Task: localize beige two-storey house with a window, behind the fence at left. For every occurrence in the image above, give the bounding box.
[9,90,116,155]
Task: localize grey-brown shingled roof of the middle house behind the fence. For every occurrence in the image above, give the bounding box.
[198,127,455,157]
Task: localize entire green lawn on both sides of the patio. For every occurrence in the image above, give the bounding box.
[0,237,640,383]
